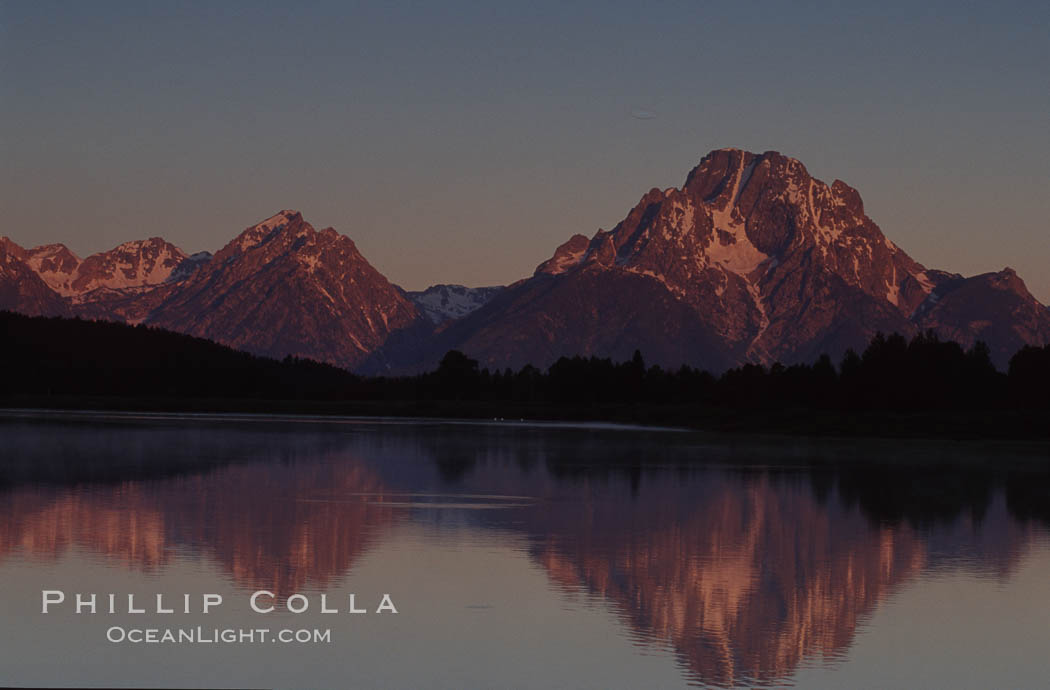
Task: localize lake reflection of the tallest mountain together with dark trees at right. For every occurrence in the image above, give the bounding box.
[434,436,1047,685]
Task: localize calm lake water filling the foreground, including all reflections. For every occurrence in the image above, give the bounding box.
[0,414,1050,688]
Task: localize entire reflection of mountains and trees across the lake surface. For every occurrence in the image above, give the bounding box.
[0,417,1046,685]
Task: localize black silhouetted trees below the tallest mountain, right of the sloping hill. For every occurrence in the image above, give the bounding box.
[373,333,1050,411]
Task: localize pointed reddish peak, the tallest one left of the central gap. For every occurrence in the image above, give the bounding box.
[147,211,420,368]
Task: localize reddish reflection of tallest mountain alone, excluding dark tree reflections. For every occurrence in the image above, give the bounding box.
[520,477,1026,685]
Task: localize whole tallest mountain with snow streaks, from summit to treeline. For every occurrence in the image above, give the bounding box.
[403,149,1050,371]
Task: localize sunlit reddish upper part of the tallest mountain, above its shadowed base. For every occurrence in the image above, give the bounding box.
[538,148,931,309]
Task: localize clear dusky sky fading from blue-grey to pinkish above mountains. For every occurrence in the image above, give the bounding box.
[0,0,1050,302]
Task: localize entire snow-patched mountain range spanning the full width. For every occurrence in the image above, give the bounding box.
[0,149,1050,374]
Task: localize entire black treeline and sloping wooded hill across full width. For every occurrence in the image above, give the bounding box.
[0,312,1050,413]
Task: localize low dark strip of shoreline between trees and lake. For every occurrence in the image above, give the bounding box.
[0,396,1050,445]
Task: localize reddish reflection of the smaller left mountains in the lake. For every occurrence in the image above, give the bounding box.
[0,420,392,594]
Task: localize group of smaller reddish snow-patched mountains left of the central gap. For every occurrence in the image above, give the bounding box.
[0,211,425,368]
